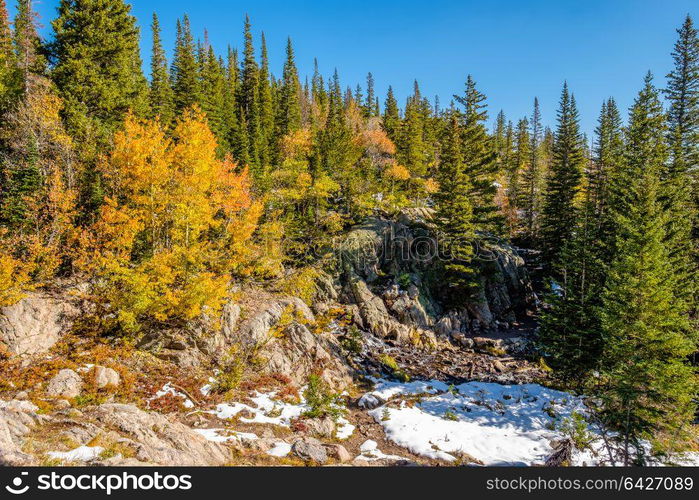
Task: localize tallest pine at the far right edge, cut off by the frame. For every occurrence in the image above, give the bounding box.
[662,16,699,311]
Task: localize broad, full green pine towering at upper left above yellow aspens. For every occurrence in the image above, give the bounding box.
[51,0,148,140]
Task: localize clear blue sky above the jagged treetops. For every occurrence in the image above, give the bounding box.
[15,0,699,132]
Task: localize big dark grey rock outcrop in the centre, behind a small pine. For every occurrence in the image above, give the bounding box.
[338,209,535,343]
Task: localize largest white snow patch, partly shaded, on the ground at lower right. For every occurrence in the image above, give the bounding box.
[369,381,589,465]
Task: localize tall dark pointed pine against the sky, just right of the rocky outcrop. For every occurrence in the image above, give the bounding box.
[541,84,586,279]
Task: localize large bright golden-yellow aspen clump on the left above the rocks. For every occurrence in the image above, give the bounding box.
[80,108,261,333]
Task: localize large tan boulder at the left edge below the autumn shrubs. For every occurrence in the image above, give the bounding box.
[0,292,78,355]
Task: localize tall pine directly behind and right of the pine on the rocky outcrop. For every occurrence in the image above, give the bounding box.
[454,75,501,232]
